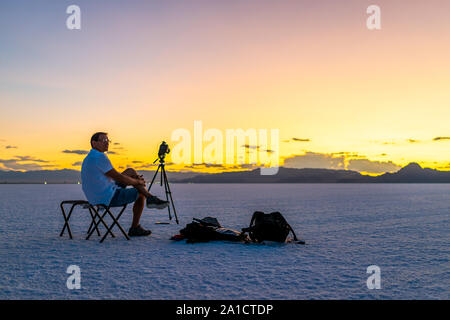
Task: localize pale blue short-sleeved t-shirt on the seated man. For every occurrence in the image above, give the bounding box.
[81,149,117,205]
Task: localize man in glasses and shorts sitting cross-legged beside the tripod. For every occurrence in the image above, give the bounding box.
[81,132,169,237]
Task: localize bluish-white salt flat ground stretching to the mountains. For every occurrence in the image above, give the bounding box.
[0,184,450,299]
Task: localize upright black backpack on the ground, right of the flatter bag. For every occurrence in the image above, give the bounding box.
[242,211,305,244]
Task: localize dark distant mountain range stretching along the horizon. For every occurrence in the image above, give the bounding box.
[0,163,450,184]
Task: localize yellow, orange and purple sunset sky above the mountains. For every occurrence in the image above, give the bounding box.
[0,0,450,174]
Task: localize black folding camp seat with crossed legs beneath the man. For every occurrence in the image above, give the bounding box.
[60,200,130,242]
